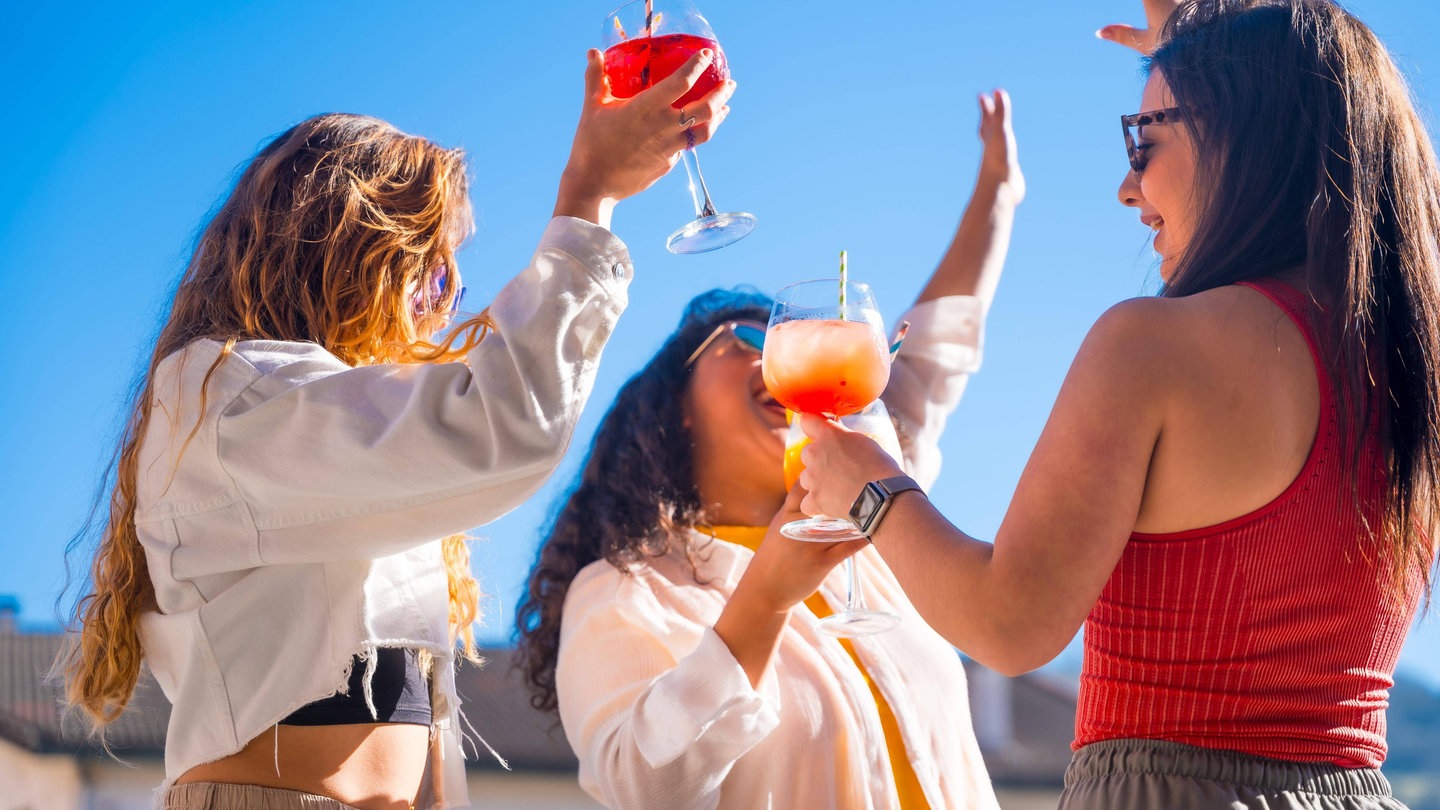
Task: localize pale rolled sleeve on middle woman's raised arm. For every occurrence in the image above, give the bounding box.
[881,295,985,489]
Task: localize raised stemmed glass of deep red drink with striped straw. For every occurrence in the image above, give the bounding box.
[600,0,756,254]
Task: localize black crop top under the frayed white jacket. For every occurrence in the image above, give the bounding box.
[279,647,432,725]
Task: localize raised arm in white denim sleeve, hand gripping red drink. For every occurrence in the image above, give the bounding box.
[147,52,733,572]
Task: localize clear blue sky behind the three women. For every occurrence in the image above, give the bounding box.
[0,0,1440,687]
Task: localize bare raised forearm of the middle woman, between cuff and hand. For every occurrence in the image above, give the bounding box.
[916,170,1017,308]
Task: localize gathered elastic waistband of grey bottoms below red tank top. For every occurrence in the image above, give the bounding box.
[1066,739,1391,797]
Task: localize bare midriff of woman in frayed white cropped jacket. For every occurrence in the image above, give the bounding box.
[176,724,431,810]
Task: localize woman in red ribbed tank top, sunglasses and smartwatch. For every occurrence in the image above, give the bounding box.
[801,0,1440,809]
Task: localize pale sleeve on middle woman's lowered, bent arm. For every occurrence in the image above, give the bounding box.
[556,574,779,809]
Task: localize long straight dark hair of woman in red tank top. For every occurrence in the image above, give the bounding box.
[1151,0,1440,594]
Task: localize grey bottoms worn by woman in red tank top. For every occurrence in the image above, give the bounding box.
[1060,739,1405,810]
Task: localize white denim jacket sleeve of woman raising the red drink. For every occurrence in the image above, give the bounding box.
[147,218,632,568]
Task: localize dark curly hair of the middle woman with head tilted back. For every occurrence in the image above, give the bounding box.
[516,290,770,712]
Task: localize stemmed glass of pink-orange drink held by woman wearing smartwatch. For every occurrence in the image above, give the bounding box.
[762,278,890,543]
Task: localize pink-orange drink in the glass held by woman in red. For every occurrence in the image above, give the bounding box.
[763,319,890,417]
